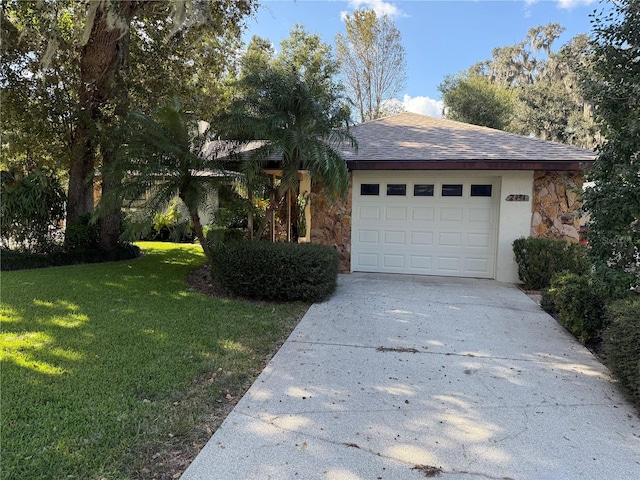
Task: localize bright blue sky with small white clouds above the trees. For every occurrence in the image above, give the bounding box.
[245,0,602,115]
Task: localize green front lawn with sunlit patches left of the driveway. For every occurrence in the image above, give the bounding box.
[0,243,308,480]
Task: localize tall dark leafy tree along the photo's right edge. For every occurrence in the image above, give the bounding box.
[583,0,640,285]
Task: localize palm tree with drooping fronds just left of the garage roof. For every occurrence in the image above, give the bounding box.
[222,64,357,240]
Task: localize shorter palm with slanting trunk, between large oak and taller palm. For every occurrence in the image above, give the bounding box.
[103,99,224,258]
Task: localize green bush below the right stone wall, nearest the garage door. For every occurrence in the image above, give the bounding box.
[513,237,590,290]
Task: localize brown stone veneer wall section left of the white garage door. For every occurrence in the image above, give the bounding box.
[311,177,351,273]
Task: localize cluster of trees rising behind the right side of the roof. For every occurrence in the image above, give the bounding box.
[439,23,597,148]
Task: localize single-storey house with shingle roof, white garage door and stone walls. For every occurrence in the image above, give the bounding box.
[309,113,595,282]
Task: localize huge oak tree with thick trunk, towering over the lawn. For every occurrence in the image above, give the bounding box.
[0,0,256,248]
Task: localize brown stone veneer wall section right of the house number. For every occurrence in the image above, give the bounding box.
[531,170,583,242]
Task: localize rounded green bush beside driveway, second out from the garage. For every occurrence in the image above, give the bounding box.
[541,272,606,342]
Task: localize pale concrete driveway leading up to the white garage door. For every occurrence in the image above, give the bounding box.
[182,274,640,480]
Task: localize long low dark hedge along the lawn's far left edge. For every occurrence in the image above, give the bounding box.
[0,245,140,271]
